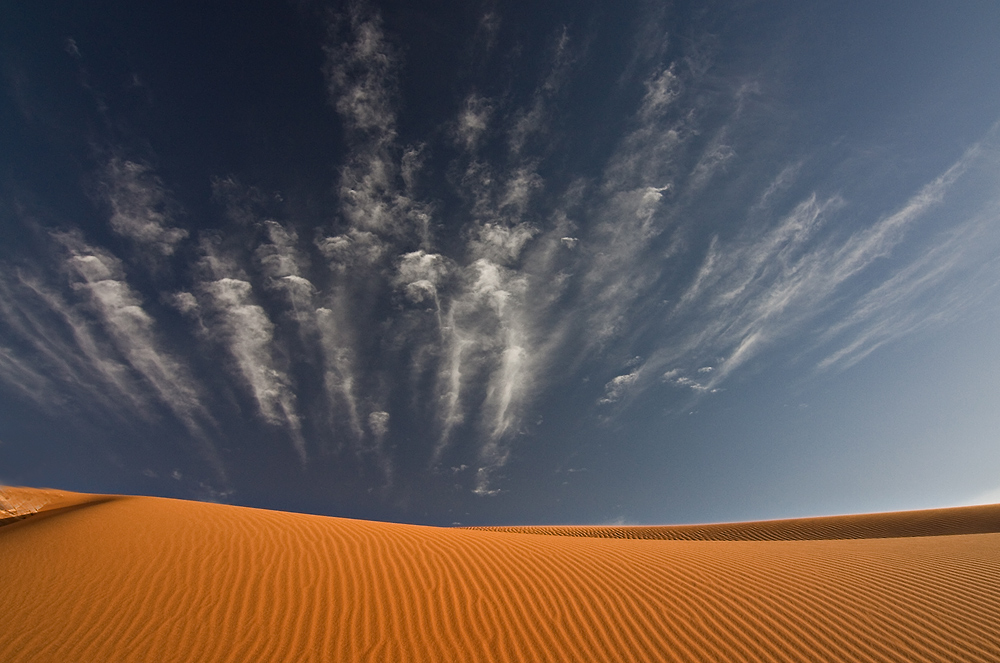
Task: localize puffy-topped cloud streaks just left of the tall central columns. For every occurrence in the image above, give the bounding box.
[207,184,372,461]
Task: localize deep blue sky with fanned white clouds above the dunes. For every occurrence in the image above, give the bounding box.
[0,0,1000,525]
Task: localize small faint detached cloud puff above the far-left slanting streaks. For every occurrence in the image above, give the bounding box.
[104,157,188,256]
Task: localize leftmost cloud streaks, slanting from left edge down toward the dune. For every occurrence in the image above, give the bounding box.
[0,232,226,482]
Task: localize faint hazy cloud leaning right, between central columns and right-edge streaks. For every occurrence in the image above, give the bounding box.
[579,48,735,353]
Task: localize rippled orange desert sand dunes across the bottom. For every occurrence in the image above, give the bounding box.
[0,489,1000,663]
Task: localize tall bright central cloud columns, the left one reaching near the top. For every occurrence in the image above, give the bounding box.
[317,8,580,492]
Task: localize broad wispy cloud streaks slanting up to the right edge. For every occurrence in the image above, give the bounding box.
[615,127,997,400]
